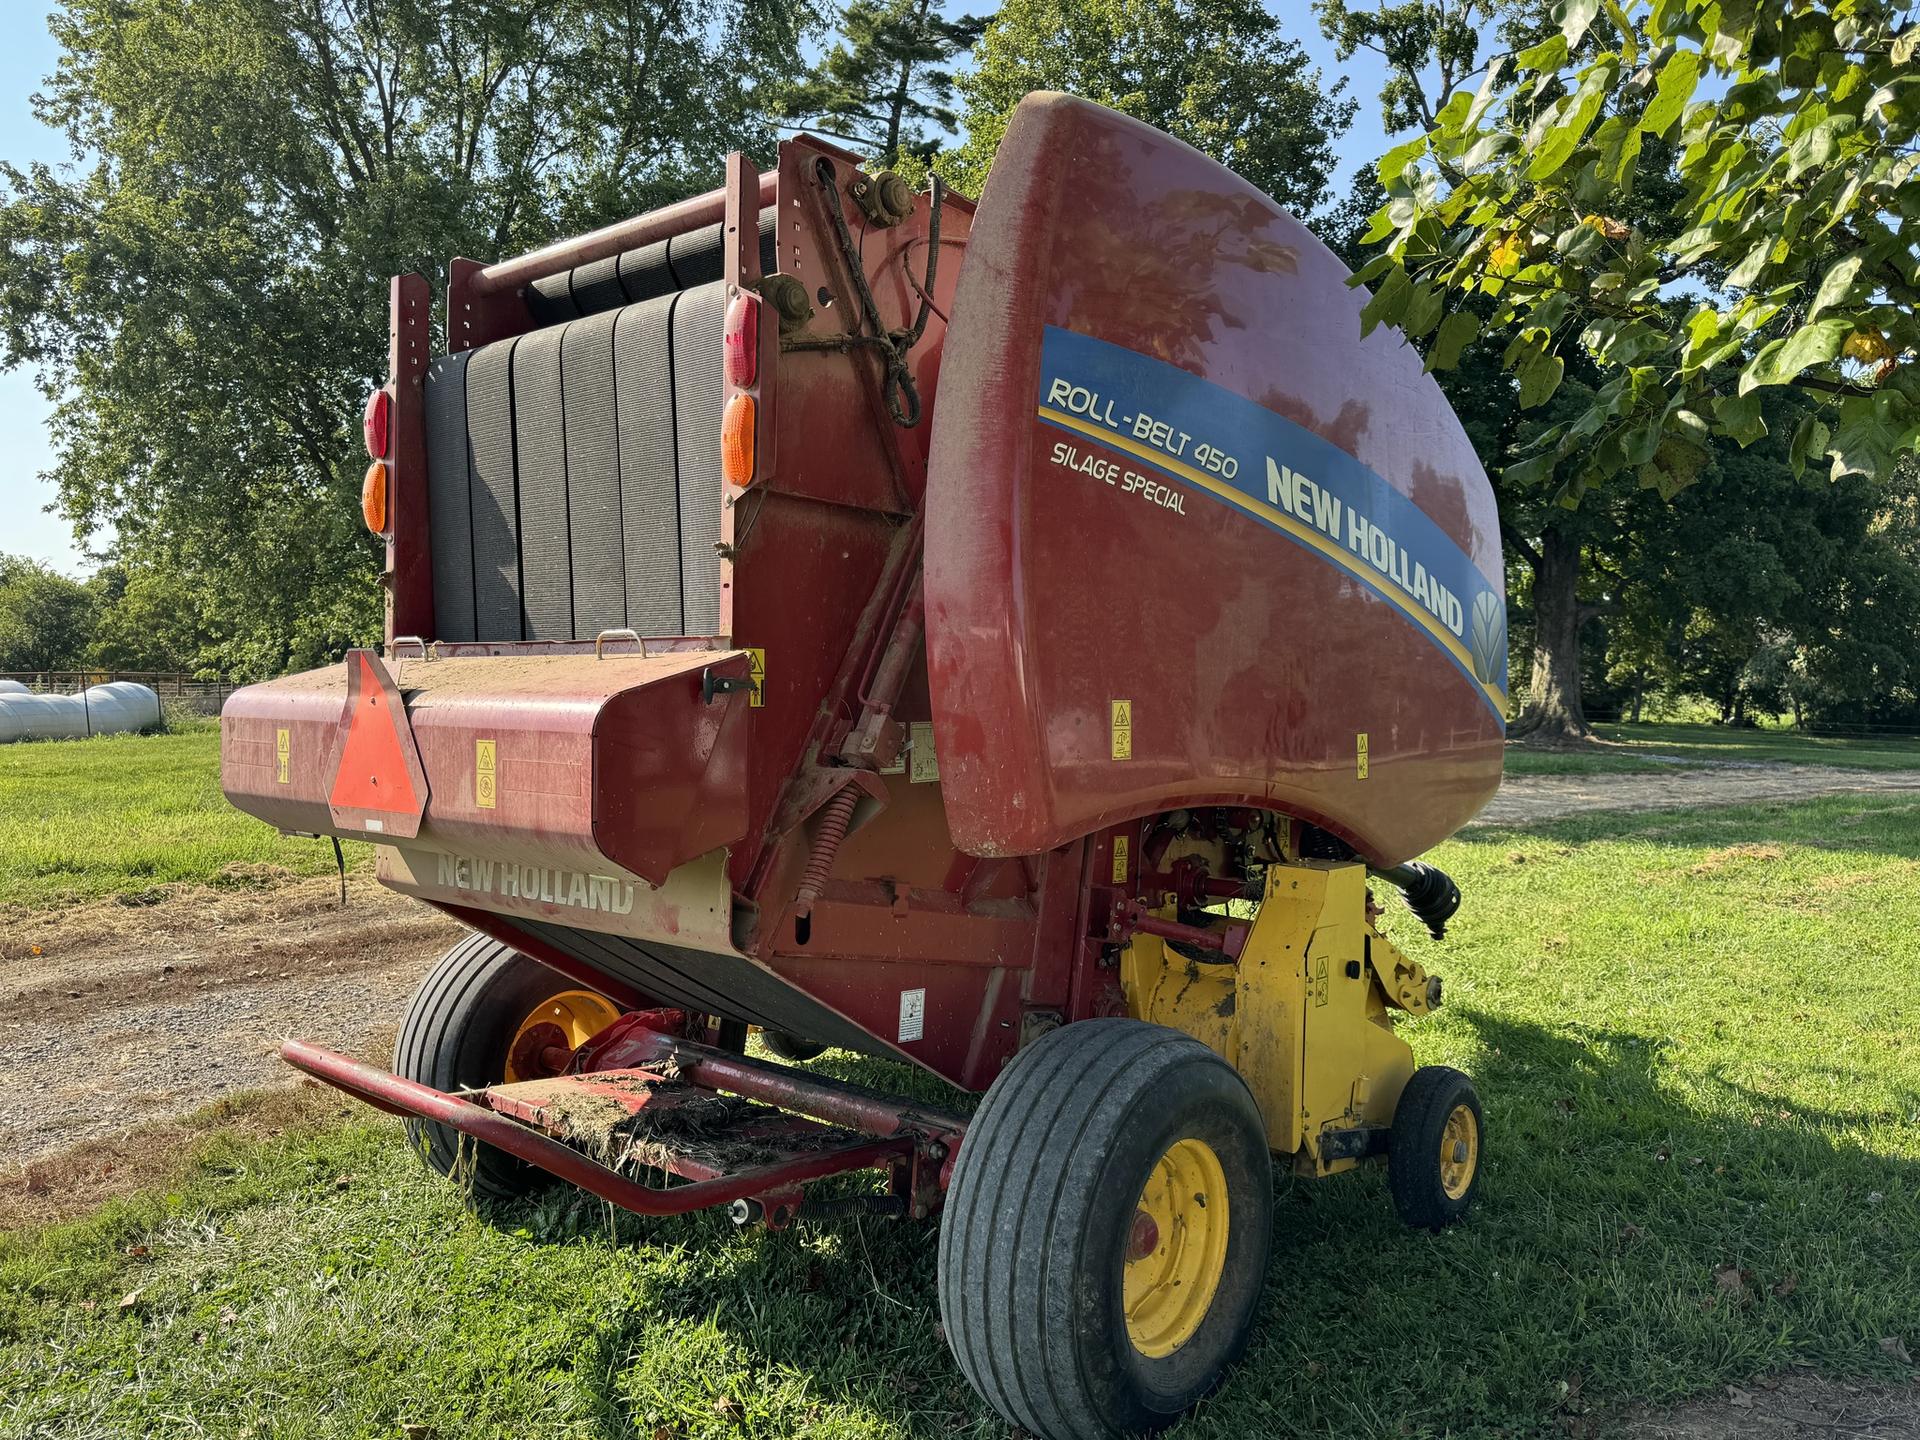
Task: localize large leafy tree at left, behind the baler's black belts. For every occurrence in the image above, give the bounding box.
[0,0,801,676]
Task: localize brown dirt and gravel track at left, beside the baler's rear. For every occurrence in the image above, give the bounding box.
[0,876,459,1165]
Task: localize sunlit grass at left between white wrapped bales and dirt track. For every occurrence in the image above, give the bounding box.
[0,722,371,910]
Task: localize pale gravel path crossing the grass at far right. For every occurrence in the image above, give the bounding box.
[1473,764,1920,826]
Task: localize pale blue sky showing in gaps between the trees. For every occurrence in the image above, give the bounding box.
[0,0,1386,574]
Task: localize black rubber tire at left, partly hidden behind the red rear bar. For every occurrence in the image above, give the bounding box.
[394,933,599,1204]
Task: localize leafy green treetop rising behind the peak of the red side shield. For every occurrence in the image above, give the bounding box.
[941,0,1354,215]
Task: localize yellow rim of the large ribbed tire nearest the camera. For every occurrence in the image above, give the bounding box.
[1121,1140,1229,1359]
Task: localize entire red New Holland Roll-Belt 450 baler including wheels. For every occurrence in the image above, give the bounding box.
[221,96,1505,1436]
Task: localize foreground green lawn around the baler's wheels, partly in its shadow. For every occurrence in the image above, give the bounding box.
[0,795,1920,1440]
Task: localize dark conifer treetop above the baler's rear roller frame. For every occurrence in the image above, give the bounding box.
[774,0,987,161]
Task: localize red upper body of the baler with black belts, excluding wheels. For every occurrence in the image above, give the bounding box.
[223,96,1505,1089]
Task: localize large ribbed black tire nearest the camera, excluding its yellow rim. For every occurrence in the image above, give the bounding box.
[939,1020,1273,1440]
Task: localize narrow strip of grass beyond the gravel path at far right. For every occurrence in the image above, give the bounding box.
[1507,724,1920,776]
